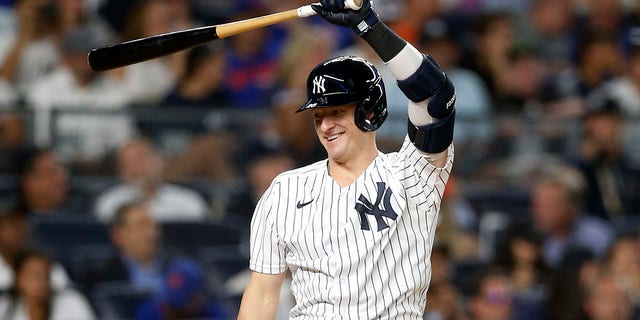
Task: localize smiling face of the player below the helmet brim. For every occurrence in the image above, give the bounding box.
[313,105,373,163]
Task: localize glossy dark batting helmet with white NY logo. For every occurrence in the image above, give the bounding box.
[296,56,387,131]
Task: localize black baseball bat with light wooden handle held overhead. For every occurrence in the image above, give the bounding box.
[87,0,362,71]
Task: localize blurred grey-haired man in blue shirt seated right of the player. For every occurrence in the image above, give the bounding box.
[531,164,615,268]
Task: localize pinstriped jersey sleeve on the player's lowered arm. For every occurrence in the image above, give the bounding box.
[249,182,286,274]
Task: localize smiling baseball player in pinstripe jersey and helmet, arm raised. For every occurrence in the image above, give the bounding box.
[238,0,455,320]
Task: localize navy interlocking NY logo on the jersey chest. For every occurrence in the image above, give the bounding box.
[355,182,398,231]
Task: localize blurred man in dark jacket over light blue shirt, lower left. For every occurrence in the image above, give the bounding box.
[77,202,171,292]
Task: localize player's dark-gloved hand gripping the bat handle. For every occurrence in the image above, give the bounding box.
[311,0,380,36]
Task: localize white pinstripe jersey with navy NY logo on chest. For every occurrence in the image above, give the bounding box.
[249,138,453,319]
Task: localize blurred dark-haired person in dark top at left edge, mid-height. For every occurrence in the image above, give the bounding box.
[18,148,93,215]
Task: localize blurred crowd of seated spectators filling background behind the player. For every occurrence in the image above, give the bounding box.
[0,0,640,320]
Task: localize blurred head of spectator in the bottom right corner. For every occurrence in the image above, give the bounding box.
[583,272,637,320]
